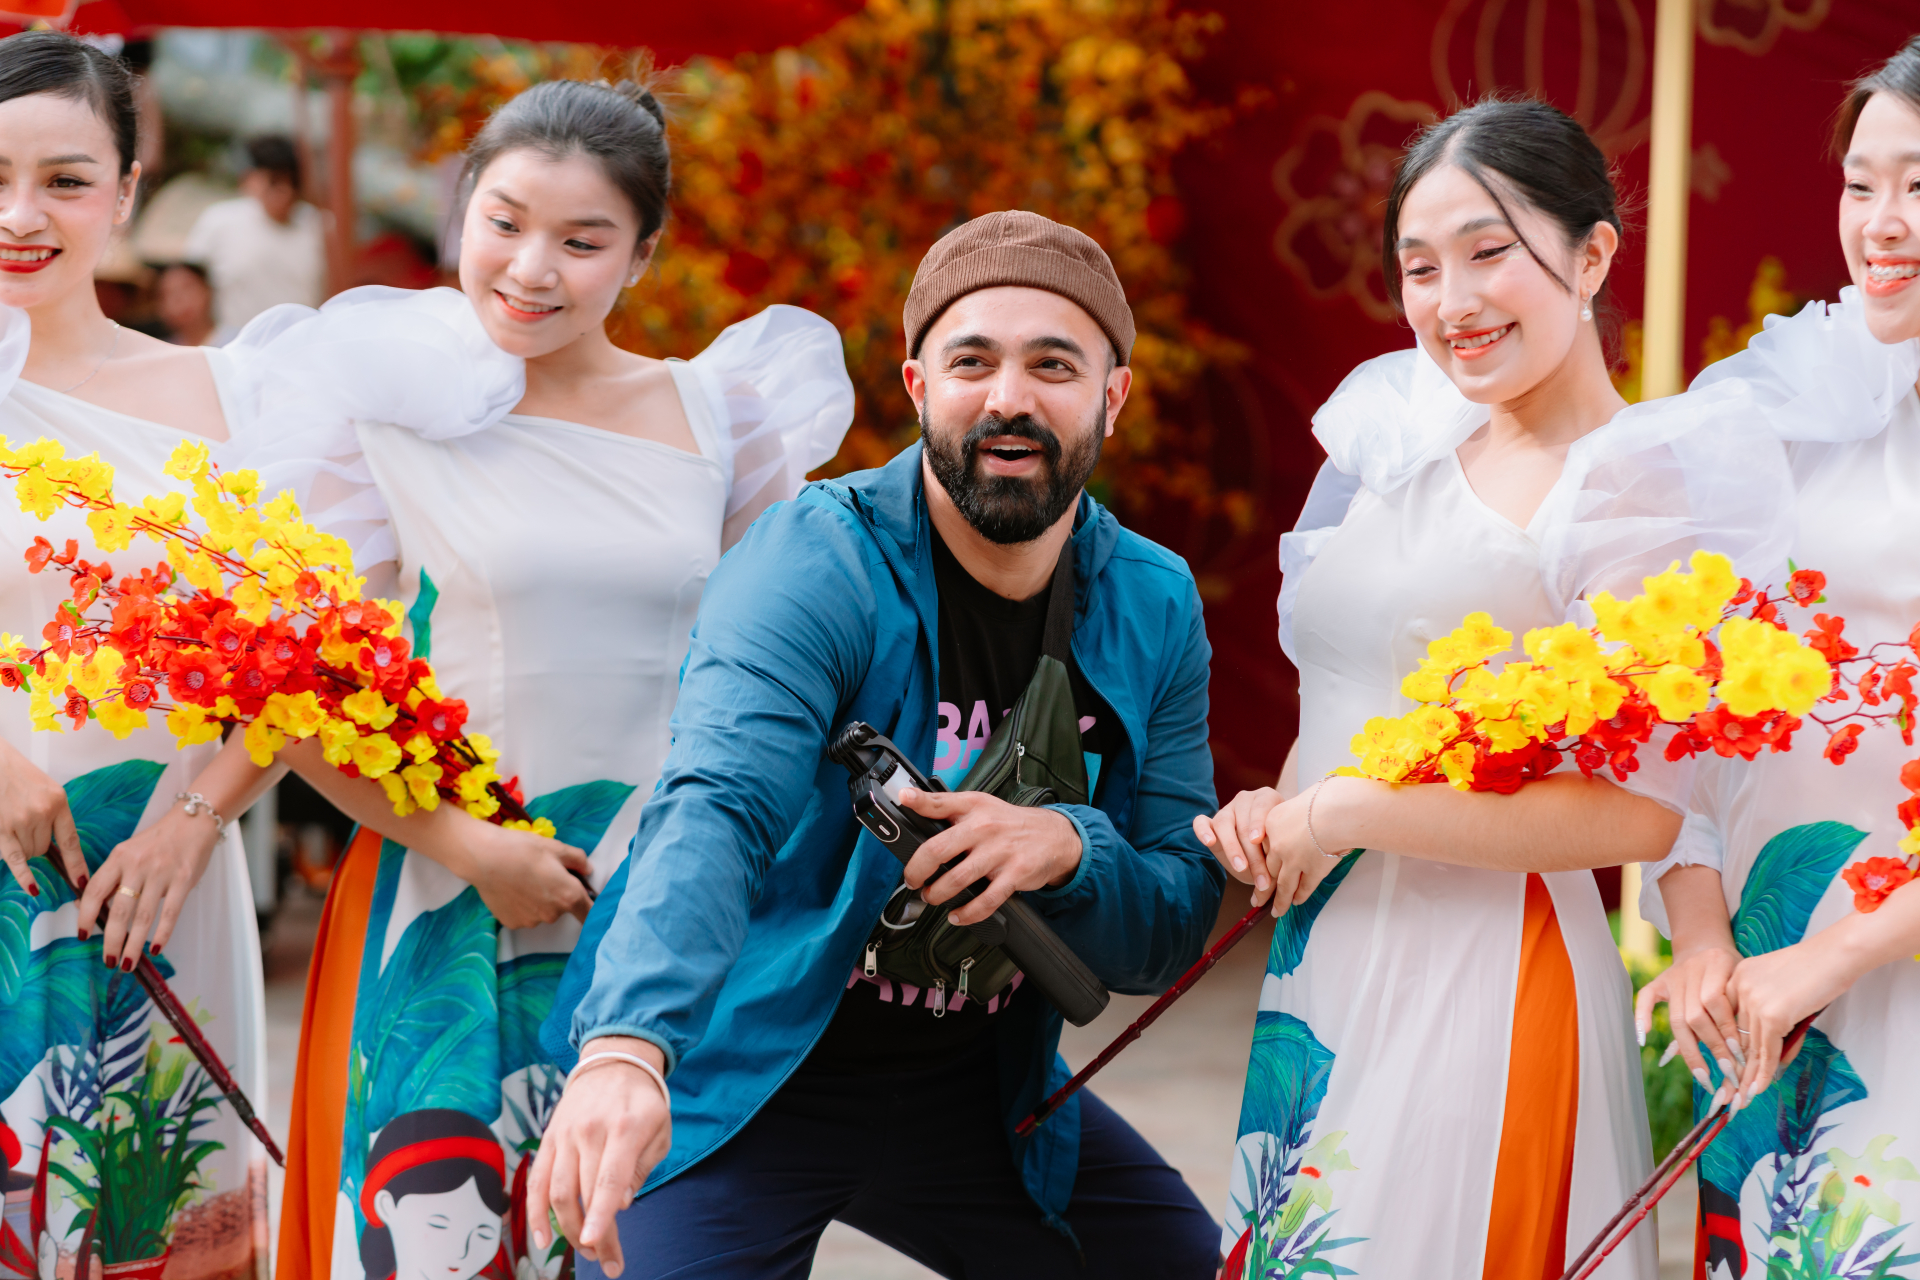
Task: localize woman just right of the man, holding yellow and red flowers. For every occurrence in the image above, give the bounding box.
[1196,102,1797,1280]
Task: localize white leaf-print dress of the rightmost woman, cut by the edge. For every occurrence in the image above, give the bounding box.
[1642,288,1920,1280]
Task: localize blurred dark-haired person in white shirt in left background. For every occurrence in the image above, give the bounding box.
[186,134,326,338]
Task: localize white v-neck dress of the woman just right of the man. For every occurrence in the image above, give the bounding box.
[1223,339,1786,1280]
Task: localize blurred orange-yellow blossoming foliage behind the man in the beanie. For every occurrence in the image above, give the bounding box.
[392,0,1254,530]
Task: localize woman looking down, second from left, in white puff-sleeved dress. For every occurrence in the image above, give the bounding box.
[230,81,852,1280]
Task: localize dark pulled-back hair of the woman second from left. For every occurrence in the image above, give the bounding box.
[461,81,674,240]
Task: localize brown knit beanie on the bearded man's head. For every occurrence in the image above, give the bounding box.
[902,209,1133,365]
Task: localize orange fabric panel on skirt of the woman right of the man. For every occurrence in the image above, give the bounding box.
[1480,875,1580,1280]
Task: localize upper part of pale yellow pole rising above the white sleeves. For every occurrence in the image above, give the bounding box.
[1642,0,1693,399]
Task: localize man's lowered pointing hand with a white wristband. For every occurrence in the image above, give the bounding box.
[526,1036,674,1276]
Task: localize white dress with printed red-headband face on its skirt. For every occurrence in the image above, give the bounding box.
[216,290,852,1280]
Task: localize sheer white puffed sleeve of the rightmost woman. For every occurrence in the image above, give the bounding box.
[1693,286,1920,443]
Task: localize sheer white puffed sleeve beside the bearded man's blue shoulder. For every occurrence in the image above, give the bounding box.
[689,305,852,547]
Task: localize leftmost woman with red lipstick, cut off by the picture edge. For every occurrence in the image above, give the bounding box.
[0,33,275,1276]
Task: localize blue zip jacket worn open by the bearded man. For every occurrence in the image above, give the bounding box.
[541,445,1225,1228]
